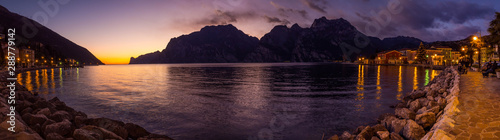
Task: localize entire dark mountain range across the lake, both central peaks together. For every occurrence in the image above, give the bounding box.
[130,17,430,64]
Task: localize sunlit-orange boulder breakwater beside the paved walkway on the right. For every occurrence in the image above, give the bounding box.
[329,67,460,140]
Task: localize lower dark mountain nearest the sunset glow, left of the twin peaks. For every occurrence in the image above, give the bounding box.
[130,24,259,64]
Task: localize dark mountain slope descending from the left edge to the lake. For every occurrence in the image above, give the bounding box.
[0,6,103,64]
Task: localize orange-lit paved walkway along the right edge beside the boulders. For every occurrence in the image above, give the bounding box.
[450,72,500,140]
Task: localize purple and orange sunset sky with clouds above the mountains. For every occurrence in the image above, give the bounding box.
[0,0,500,64]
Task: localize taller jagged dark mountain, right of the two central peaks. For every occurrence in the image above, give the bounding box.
[245,17,378,62]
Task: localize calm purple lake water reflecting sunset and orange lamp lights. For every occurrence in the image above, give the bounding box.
[18,63,438,140]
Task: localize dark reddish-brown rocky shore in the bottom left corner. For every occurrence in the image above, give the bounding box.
[0,71,171,140]
